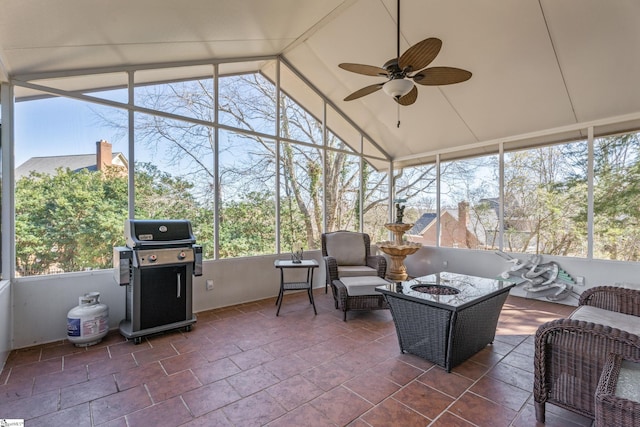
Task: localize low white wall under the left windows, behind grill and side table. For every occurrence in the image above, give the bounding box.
[11,251,325,350]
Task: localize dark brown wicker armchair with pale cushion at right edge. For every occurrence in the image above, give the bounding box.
[533,286,640,423]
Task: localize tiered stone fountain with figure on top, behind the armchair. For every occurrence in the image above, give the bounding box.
[377,203,422,282]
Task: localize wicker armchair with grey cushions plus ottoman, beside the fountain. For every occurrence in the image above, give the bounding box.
[322,231,388,321]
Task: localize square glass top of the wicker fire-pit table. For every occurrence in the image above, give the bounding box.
[376,272,515,307]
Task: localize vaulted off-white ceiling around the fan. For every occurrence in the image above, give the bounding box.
[0,0,640,164]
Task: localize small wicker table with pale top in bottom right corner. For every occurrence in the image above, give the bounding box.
[595,353,640,427]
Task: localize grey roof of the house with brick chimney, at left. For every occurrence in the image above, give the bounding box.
[15,152,127,180]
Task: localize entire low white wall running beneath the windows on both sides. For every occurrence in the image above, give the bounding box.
[10,247,640,352]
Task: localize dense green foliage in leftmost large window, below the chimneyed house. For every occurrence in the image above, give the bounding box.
[16,168,127,275]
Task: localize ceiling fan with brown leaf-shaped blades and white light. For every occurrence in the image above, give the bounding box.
[338,0,471,105]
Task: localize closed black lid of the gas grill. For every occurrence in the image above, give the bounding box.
[124,219,196,249]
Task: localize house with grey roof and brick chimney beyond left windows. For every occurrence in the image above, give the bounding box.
[15,139,129,180]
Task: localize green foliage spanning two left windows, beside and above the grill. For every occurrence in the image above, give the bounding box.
[15,164,212,276]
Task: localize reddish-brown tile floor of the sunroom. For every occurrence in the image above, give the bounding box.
[0,289,591,427]
